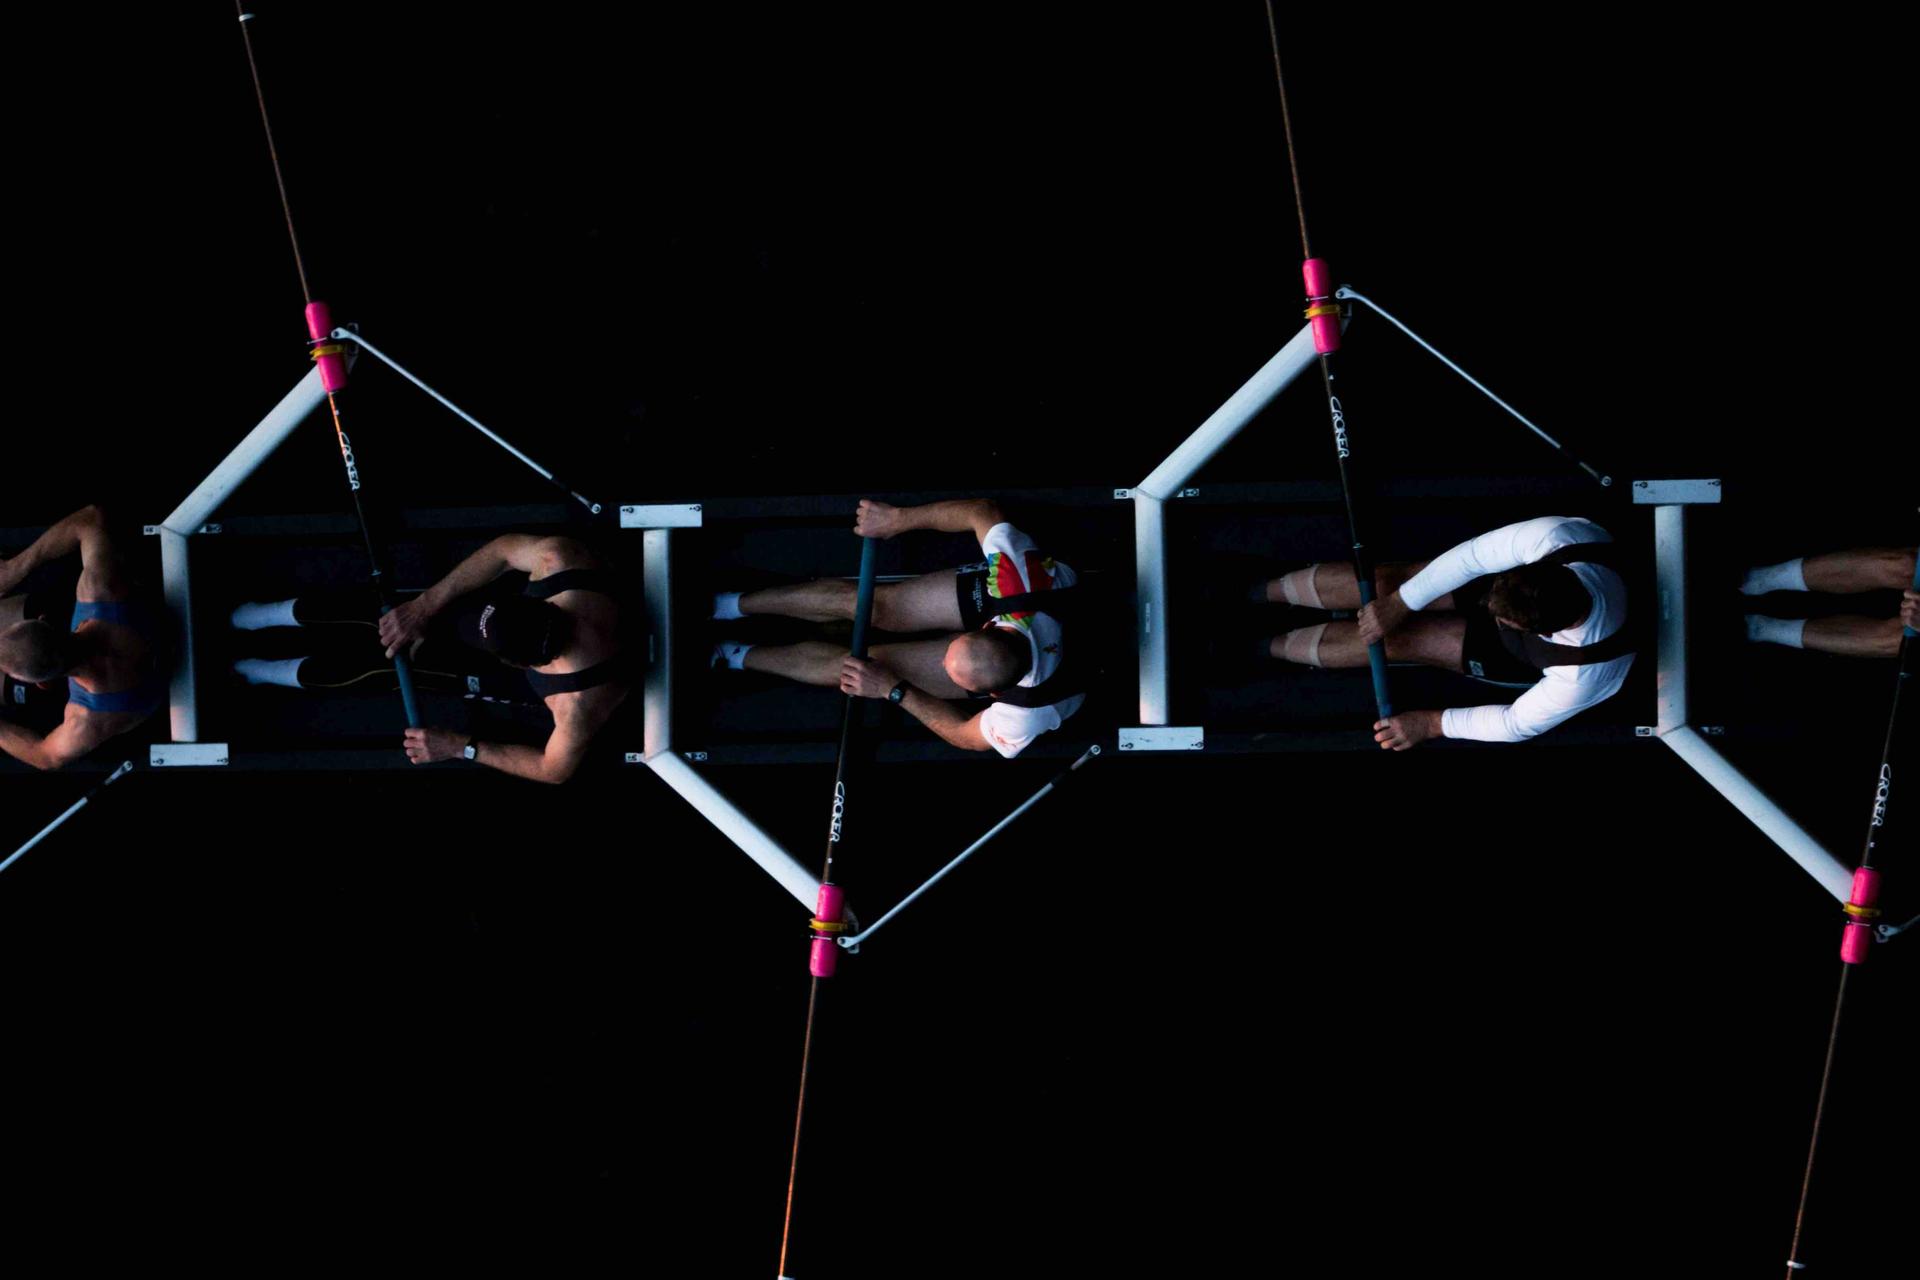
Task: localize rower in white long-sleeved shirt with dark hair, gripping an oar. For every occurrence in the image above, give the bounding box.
[1267,516,1634,750]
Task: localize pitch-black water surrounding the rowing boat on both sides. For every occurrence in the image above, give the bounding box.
[0,6,1920,1276]
